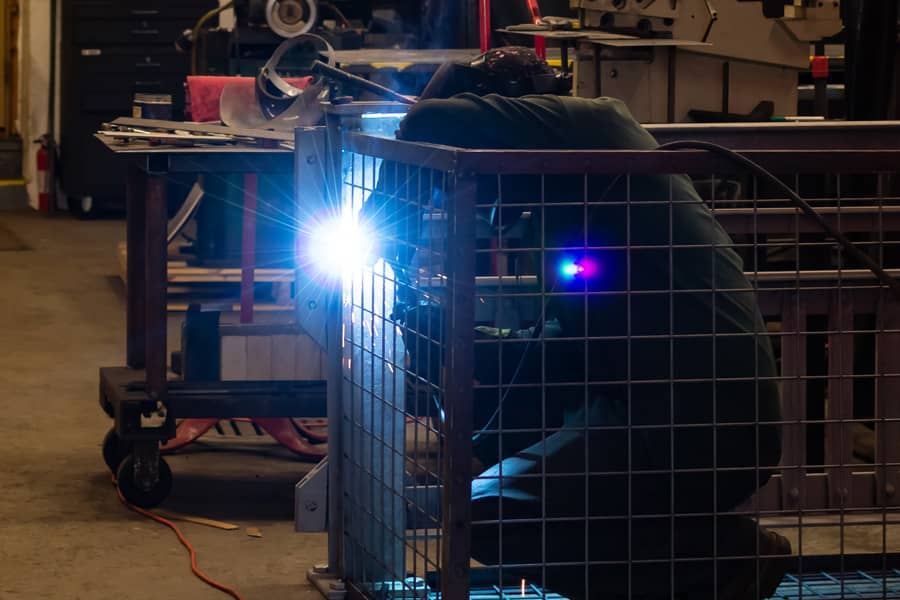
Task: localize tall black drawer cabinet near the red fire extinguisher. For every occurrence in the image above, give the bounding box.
[59,0,218,208]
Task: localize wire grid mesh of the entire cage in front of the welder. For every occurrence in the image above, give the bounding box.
[330,134,900,598]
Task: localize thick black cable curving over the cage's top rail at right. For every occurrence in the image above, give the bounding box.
[659,140,900,300]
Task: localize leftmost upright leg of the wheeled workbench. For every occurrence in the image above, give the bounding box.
[125,165,147,369]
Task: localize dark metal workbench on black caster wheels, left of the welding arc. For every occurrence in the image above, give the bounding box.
[98,136,325,506]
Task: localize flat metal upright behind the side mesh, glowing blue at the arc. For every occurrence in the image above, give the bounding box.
[342,150,406,585]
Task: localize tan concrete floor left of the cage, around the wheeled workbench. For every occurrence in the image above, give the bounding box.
[0,212,325,600]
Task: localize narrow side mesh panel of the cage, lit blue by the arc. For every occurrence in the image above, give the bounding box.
[332,124,474,597]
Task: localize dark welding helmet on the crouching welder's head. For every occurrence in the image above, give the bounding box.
[419,46,572,99]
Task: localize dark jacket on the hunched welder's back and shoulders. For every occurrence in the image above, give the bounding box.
[366,94,780,508]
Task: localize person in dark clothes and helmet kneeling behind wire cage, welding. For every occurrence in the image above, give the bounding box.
[364,47,790,600]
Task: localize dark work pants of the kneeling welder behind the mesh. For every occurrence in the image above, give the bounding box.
[472,420,780,599]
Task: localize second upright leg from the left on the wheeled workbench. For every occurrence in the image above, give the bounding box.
[144,173,168,402]
